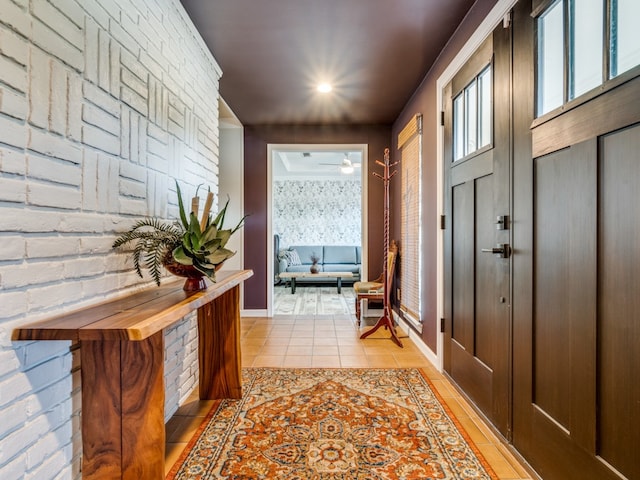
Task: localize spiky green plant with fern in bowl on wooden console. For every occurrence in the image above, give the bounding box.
[113,180,246,291]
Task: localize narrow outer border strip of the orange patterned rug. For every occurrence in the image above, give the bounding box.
[165,367,499,480]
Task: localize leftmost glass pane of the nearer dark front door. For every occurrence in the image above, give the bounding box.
[537,1,564,115]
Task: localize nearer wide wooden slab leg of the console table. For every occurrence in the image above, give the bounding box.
[80,331,165,480]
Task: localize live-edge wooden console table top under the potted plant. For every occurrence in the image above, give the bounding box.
[12,270,253,341]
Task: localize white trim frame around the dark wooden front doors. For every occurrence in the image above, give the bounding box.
[434,0,518,372]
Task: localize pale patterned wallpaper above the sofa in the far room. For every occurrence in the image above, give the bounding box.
[273,180,362,248]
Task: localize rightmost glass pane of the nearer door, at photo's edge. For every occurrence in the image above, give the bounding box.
[611,0,640,77]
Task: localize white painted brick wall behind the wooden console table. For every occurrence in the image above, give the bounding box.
[0,0,221,480]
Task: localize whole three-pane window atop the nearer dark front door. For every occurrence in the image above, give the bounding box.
[537,0,640,116]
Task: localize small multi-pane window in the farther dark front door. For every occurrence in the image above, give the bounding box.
[453,65,493,161]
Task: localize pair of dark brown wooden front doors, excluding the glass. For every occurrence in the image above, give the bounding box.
[444,0,640,480]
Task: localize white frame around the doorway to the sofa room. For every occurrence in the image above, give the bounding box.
[267,143,369,317]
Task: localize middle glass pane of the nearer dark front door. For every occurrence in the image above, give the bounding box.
[570,0,604,98]
